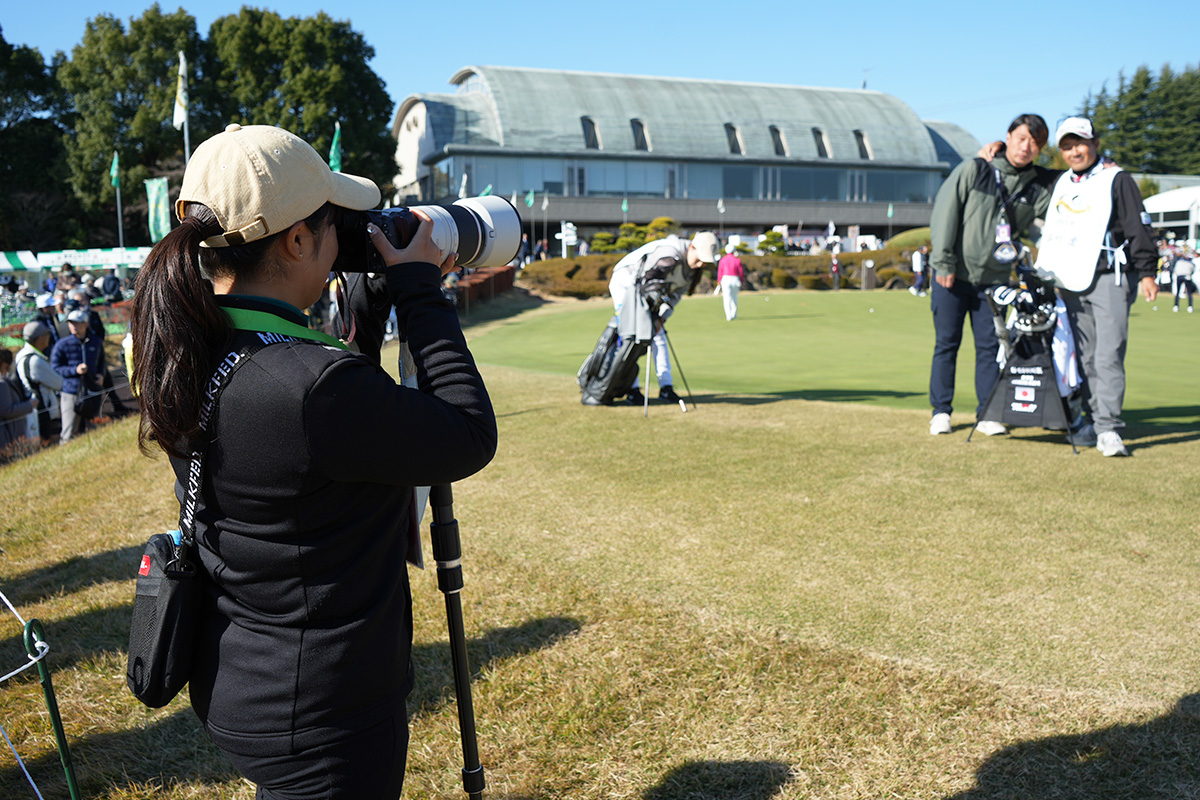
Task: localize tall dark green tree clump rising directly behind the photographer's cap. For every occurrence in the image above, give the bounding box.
[48,4,395,246]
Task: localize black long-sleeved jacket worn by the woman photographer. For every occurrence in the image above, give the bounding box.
[173,264,496,756]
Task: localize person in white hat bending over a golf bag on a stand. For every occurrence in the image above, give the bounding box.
[608,230,719,405]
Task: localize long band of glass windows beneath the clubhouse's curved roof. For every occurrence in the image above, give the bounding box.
[430,155,942,203]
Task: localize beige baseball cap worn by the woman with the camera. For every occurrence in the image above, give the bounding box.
[175,125,379,247]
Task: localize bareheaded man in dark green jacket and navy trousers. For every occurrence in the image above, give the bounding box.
[929,114,1058,435]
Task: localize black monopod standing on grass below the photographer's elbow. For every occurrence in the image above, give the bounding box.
[430,483,485,800]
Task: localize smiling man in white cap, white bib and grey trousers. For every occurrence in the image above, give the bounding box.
[1034,116,1158,456]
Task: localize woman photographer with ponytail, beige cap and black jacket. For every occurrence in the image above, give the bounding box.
[132,125,496,800]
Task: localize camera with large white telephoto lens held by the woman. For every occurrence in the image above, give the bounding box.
[334,196,521,272]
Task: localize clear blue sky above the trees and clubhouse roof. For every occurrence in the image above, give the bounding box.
[0,0,1200,142]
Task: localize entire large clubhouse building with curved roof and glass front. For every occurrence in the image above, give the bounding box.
[392,66,979,241]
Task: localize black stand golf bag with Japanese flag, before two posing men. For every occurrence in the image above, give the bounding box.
[979,267,1070,431]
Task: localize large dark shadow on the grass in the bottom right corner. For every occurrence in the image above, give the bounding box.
[949,694,1200,800]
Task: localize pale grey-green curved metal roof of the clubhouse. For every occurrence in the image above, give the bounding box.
[395,66,979,167]
